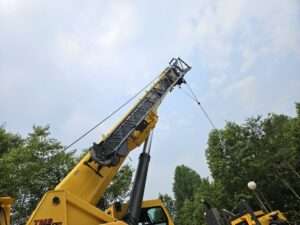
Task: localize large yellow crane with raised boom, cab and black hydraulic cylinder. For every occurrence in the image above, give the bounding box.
[0,58,191,225]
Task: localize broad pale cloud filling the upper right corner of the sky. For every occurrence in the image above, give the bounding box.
[181,0,300,76]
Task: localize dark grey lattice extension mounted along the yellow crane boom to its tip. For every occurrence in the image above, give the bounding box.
[91,58,191,166]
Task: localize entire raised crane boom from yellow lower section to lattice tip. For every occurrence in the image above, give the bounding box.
[55,58,191,205]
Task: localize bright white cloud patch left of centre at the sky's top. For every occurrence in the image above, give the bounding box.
[54,1,138,69]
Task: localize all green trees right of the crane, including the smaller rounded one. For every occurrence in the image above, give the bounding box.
[173,103,300,225]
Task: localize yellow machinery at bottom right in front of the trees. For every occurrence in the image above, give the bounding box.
[204,201,289,225]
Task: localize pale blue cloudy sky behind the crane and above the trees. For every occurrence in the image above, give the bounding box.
[0,0,300,198]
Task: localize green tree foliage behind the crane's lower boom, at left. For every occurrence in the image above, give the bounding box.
[0,126,133,225]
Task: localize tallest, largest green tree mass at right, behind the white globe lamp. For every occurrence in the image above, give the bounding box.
[206,104,300,221]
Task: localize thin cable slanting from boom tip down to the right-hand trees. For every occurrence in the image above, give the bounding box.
[181,82,226,151]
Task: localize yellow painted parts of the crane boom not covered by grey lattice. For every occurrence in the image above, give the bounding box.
[55,113,157,205]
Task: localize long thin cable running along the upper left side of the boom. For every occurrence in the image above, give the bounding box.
[64,75,160,151]
